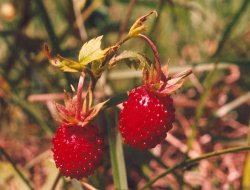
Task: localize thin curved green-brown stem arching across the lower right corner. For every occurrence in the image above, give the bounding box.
[141,146,250,190]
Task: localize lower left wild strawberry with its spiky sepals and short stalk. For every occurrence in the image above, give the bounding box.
[52,76,104,179]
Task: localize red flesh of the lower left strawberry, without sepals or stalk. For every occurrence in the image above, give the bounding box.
[52,124,104,179]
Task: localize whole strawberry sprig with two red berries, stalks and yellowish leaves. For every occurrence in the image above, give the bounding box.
[45,11,192,189]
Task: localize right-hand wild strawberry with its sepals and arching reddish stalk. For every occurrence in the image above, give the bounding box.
[119,34,192,150]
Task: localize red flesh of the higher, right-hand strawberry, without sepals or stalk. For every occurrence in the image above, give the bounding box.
[119,86,175,150]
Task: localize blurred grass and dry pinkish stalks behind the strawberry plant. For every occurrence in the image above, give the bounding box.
[0,0,250,190]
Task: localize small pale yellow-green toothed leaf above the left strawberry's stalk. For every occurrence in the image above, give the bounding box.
[79,36,109,66]
